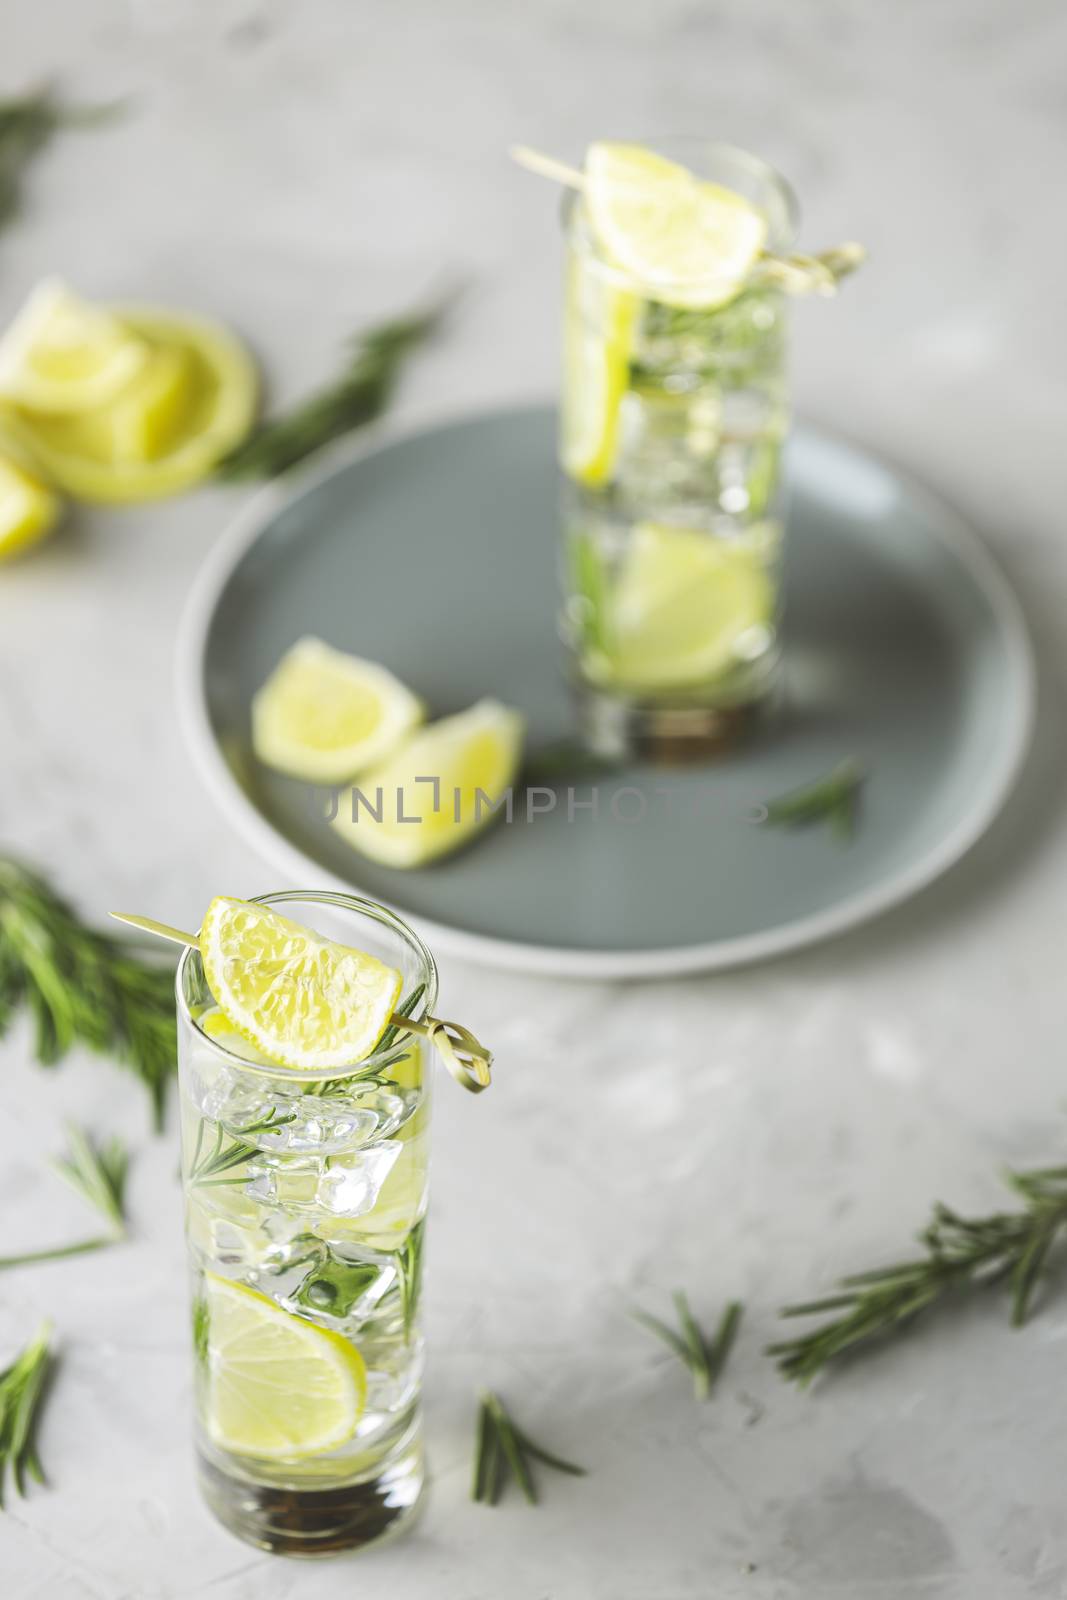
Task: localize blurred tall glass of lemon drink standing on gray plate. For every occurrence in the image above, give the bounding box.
[560,141,797,758]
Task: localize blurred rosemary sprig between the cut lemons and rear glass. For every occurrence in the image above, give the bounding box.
[218,294,454,482]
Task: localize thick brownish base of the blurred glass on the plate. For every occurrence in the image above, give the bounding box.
[573,683,781,766]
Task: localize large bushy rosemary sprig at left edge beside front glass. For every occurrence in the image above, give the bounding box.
[0,856,178,1128]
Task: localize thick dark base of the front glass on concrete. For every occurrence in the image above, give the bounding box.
[197,1434,426,1555]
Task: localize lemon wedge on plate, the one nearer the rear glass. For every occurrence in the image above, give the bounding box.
[333,699,523,867]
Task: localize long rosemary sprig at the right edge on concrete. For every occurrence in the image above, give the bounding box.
[768,1166,1067,1384]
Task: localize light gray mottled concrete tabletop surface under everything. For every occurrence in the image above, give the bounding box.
[0,0,1067,1600]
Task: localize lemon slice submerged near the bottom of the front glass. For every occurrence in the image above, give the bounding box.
[203,1274,366,1461]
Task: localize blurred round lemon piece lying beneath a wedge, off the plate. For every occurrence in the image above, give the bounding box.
[5,307,258,504]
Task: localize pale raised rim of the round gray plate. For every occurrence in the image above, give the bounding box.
[174,397,1037,979]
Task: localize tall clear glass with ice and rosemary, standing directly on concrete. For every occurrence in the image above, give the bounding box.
[178,891,437,1555]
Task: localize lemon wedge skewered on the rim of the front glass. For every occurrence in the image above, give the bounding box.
[200,894,402,1067]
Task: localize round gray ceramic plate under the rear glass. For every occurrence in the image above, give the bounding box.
[179,408,1033,976]
